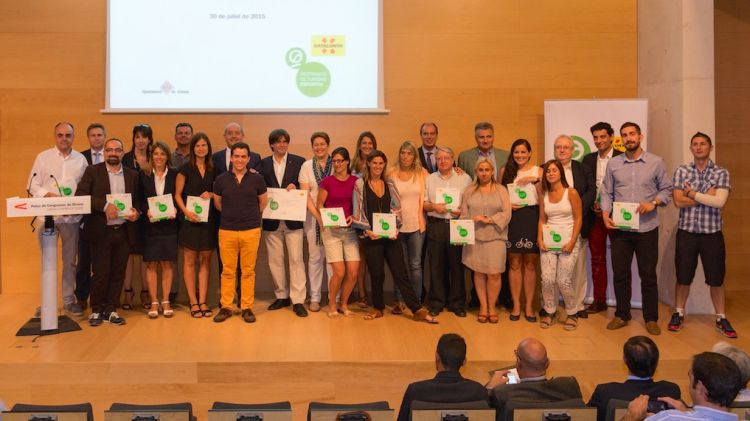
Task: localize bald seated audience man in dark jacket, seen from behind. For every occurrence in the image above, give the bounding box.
[485,338,581,419]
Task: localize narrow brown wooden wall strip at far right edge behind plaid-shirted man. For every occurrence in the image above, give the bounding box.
[714,0,750,290]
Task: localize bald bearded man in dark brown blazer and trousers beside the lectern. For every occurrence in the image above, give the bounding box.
[76,139,139,326]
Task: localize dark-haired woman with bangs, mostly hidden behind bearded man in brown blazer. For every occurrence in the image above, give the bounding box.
[122,124,154,310]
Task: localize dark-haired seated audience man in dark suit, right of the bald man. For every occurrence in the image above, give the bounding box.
[588,336,680,421]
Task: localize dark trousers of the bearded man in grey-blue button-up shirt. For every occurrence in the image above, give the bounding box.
[610,228,659,322]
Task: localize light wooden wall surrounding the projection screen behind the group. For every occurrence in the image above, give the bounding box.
[0,0,637,292]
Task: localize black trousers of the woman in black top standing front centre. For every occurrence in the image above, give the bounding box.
[363,238,422,312]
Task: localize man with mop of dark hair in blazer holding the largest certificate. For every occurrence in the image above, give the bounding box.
[261,129,307,317]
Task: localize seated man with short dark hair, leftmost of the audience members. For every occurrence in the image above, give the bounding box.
[397,333,487,421]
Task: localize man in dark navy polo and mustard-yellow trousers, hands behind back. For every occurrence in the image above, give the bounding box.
[214,142,268,323]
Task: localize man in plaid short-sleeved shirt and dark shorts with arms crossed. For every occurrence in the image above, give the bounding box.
[668,132,737,338]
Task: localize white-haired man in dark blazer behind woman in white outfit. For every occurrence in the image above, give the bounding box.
[554,135,596,318]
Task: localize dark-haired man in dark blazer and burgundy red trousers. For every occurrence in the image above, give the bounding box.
[583,122,622,314]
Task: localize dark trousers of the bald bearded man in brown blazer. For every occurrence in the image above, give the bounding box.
[91,225,130,313]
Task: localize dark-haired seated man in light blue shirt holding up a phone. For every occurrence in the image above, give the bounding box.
[622,352,742,421]
